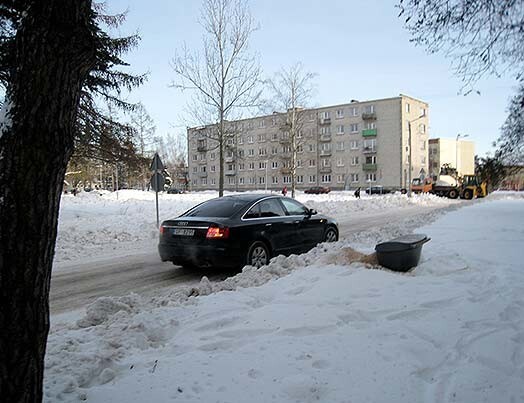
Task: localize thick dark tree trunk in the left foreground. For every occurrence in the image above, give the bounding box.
[0,0,98,403]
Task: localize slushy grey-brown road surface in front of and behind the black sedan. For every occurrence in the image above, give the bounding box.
[50,206,450,314]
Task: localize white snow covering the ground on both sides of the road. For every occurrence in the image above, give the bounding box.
[45,192,524,402]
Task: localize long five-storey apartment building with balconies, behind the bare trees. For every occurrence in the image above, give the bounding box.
[187,94,429,191]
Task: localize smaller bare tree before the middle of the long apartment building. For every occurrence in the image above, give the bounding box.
[268,63,316,197]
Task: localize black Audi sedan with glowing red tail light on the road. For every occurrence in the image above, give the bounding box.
[158,194,338,267]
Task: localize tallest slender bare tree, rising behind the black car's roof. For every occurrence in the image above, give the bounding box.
[171,0,261,197]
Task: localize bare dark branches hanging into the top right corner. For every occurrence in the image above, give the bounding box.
[398,0,524,89]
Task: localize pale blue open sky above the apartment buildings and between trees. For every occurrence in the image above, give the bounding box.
[110,0,515,156]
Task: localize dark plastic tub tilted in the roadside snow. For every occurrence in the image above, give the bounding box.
[375,234,431,271]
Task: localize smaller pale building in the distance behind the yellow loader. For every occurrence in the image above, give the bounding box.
[429,136,475,180]
